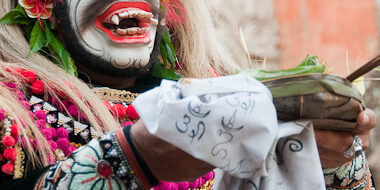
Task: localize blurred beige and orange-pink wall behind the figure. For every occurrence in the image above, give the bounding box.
[207,0,380,186]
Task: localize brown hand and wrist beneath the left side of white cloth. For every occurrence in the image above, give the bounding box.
[131,120,214,182]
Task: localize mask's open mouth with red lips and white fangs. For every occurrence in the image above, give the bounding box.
[95,2,158,44]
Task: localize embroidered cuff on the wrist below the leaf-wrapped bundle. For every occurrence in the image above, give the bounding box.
[323,152,375,190]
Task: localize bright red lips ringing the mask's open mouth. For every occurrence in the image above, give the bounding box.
[95,2,151,44]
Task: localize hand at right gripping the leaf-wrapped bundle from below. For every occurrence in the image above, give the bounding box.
[315,109,376,168]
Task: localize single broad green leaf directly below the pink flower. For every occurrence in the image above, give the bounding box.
[30,20,46,53]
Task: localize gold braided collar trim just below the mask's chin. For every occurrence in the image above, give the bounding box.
[92,88,139,104]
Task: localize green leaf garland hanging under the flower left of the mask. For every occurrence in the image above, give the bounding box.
[0,4,78,76]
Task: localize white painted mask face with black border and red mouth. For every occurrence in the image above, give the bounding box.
[54,0,160,76]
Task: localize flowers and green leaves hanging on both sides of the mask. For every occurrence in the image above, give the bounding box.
[0,0,184,79]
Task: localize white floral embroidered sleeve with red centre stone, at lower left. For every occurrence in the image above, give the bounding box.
[35,132,142,190]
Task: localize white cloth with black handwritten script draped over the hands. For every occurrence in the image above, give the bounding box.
[133,75,324,189]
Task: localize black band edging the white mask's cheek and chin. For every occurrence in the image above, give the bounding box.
[53,0,163,77]
